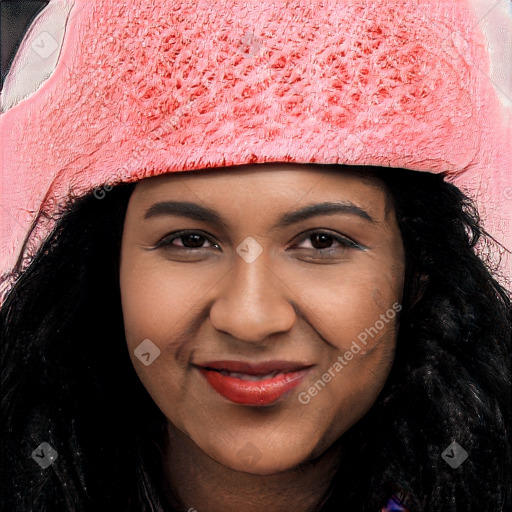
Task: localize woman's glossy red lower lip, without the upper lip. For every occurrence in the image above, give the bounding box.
[199,368,309,405]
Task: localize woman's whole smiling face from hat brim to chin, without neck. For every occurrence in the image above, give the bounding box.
[120,164,404,474]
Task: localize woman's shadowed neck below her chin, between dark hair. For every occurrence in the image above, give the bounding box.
[160,426,339,512]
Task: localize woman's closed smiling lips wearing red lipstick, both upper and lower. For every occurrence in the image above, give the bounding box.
[199,361,311,405]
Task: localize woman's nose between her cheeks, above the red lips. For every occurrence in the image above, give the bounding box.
[210,247,296,342]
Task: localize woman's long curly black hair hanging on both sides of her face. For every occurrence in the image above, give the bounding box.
[0,168,512,512]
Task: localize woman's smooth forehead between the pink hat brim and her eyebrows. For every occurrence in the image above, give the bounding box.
[130,163,393,225]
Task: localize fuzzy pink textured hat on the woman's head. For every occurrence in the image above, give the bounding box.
[0,0,512,288]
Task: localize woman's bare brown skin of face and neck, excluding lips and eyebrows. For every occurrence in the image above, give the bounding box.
[120,163,405,512]
